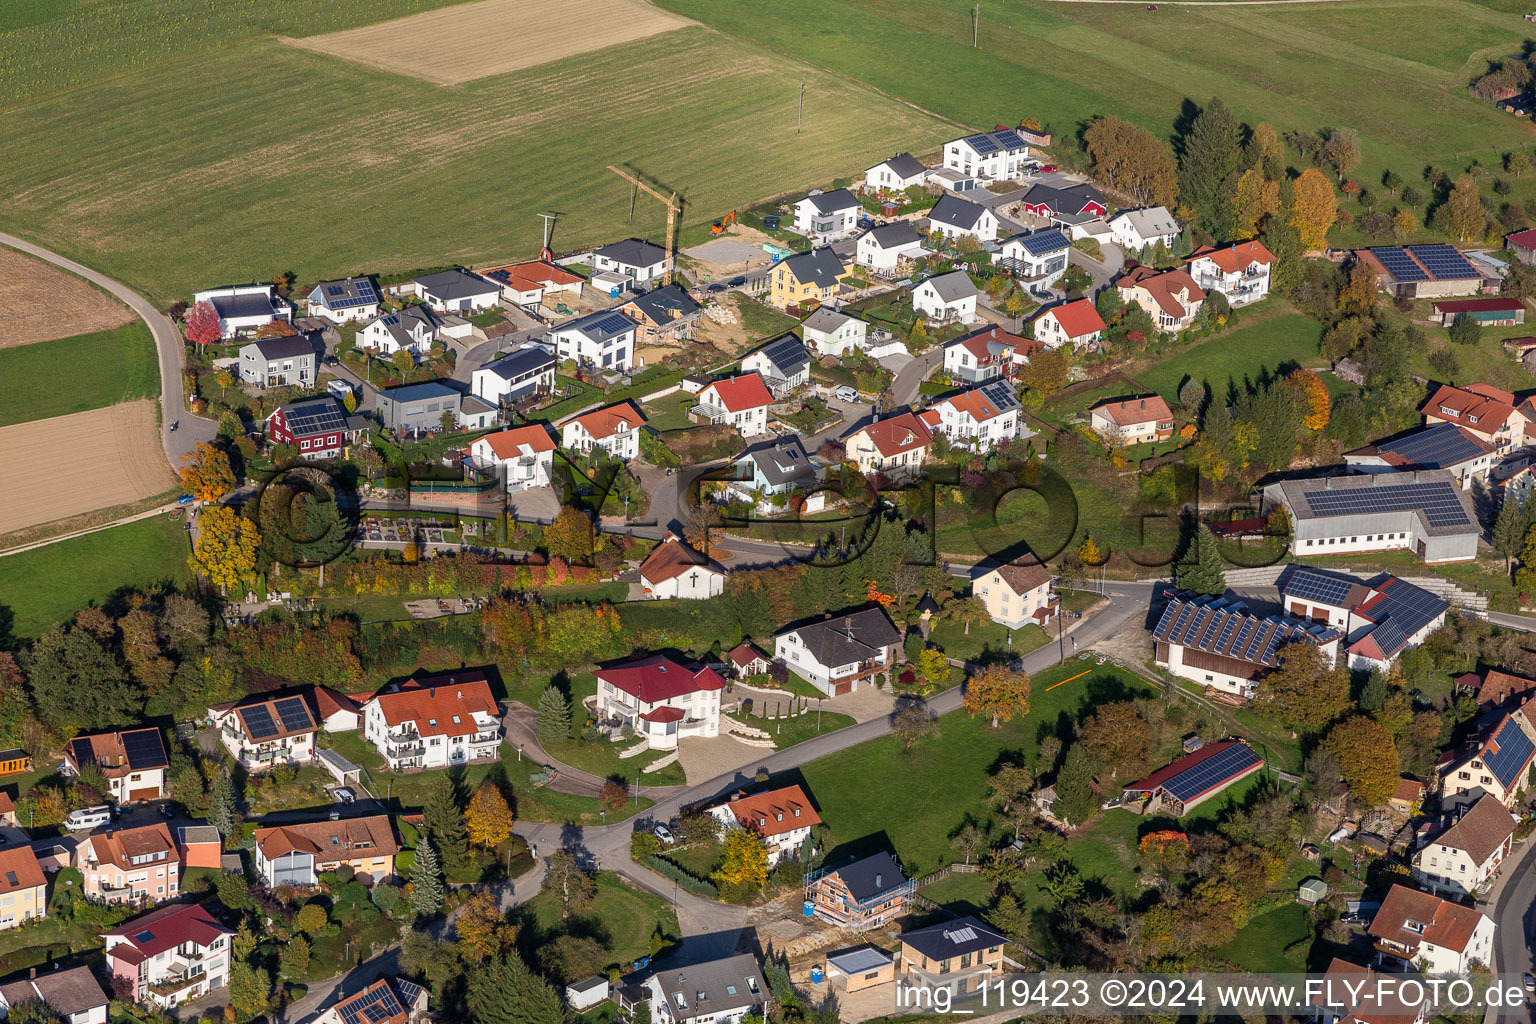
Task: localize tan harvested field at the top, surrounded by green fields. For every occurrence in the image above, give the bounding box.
[284,0,694,86]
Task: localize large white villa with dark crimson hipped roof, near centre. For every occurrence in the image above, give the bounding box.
[596,654,725,751]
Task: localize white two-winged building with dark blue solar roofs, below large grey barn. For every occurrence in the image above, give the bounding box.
[1279,565,1450,671]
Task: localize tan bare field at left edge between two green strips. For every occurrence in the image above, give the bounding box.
[0,399,175,534]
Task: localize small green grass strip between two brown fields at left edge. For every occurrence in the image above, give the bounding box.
[0,319,160,427]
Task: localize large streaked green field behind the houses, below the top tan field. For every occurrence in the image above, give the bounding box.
[0,28,951,302]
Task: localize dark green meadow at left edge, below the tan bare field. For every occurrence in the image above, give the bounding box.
[0,516,189,639]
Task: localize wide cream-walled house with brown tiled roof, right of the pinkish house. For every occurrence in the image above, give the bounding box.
[252,814,401,889]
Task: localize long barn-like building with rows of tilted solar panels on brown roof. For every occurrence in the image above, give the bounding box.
[1152,591,1342,699]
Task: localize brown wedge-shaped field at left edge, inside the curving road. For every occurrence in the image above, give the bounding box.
[0,246,134,348]
